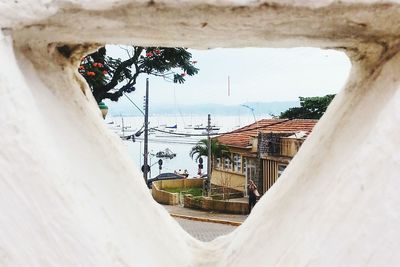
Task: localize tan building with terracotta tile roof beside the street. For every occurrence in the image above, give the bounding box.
[211,119,317,196]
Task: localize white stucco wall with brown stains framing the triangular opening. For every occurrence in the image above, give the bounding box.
[0,0,400,266]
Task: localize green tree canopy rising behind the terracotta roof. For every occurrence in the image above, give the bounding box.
[279,95,335,119]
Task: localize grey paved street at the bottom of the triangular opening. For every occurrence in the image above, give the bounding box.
[175,218,237,241]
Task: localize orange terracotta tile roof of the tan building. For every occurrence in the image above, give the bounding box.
[216,119,318,148]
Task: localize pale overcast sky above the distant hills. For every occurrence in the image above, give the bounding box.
[107,46,351,107]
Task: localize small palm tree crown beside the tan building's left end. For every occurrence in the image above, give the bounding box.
[189,139,231,166]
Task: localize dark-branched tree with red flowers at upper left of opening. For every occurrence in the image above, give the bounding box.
[79,46,199,103]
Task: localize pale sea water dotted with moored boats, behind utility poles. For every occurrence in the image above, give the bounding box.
[105,116,260,177]
